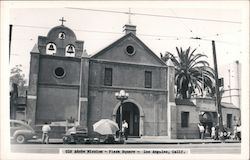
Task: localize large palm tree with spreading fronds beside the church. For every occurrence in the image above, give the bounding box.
[161,47,214,99]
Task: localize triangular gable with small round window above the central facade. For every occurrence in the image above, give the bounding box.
[91,32,166,66]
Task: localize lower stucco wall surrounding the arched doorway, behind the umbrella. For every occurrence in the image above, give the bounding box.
[88,88,167,136]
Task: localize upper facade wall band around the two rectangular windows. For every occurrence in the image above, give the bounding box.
[89,60,167,90]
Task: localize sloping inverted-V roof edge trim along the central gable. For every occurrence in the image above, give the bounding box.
[90,32,166,66]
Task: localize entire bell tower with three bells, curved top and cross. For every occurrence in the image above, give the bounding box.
[27,17,89,131]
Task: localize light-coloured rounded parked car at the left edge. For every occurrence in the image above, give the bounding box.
[10,120,37,144]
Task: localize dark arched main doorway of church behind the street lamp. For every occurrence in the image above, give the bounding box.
[116,102,140,136]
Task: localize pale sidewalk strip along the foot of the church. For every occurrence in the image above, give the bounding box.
[30,137,240,144]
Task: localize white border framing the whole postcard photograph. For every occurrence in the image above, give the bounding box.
[0,1,249,160]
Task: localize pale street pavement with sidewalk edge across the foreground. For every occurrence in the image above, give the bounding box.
[11,137,241,154]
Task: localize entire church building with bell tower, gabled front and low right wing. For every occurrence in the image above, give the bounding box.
[26,22,239,138]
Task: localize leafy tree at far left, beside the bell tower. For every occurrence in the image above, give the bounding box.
[10,64,28,96]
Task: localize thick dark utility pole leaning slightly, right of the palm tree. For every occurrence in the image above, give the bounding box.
[212,40,224,132]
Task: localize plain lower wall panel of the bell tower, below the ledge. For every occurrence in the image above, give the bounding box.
[36,86,79,124]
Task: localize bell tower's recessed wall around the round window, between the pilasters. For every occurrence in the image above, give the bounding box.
[35,55,81,124]
